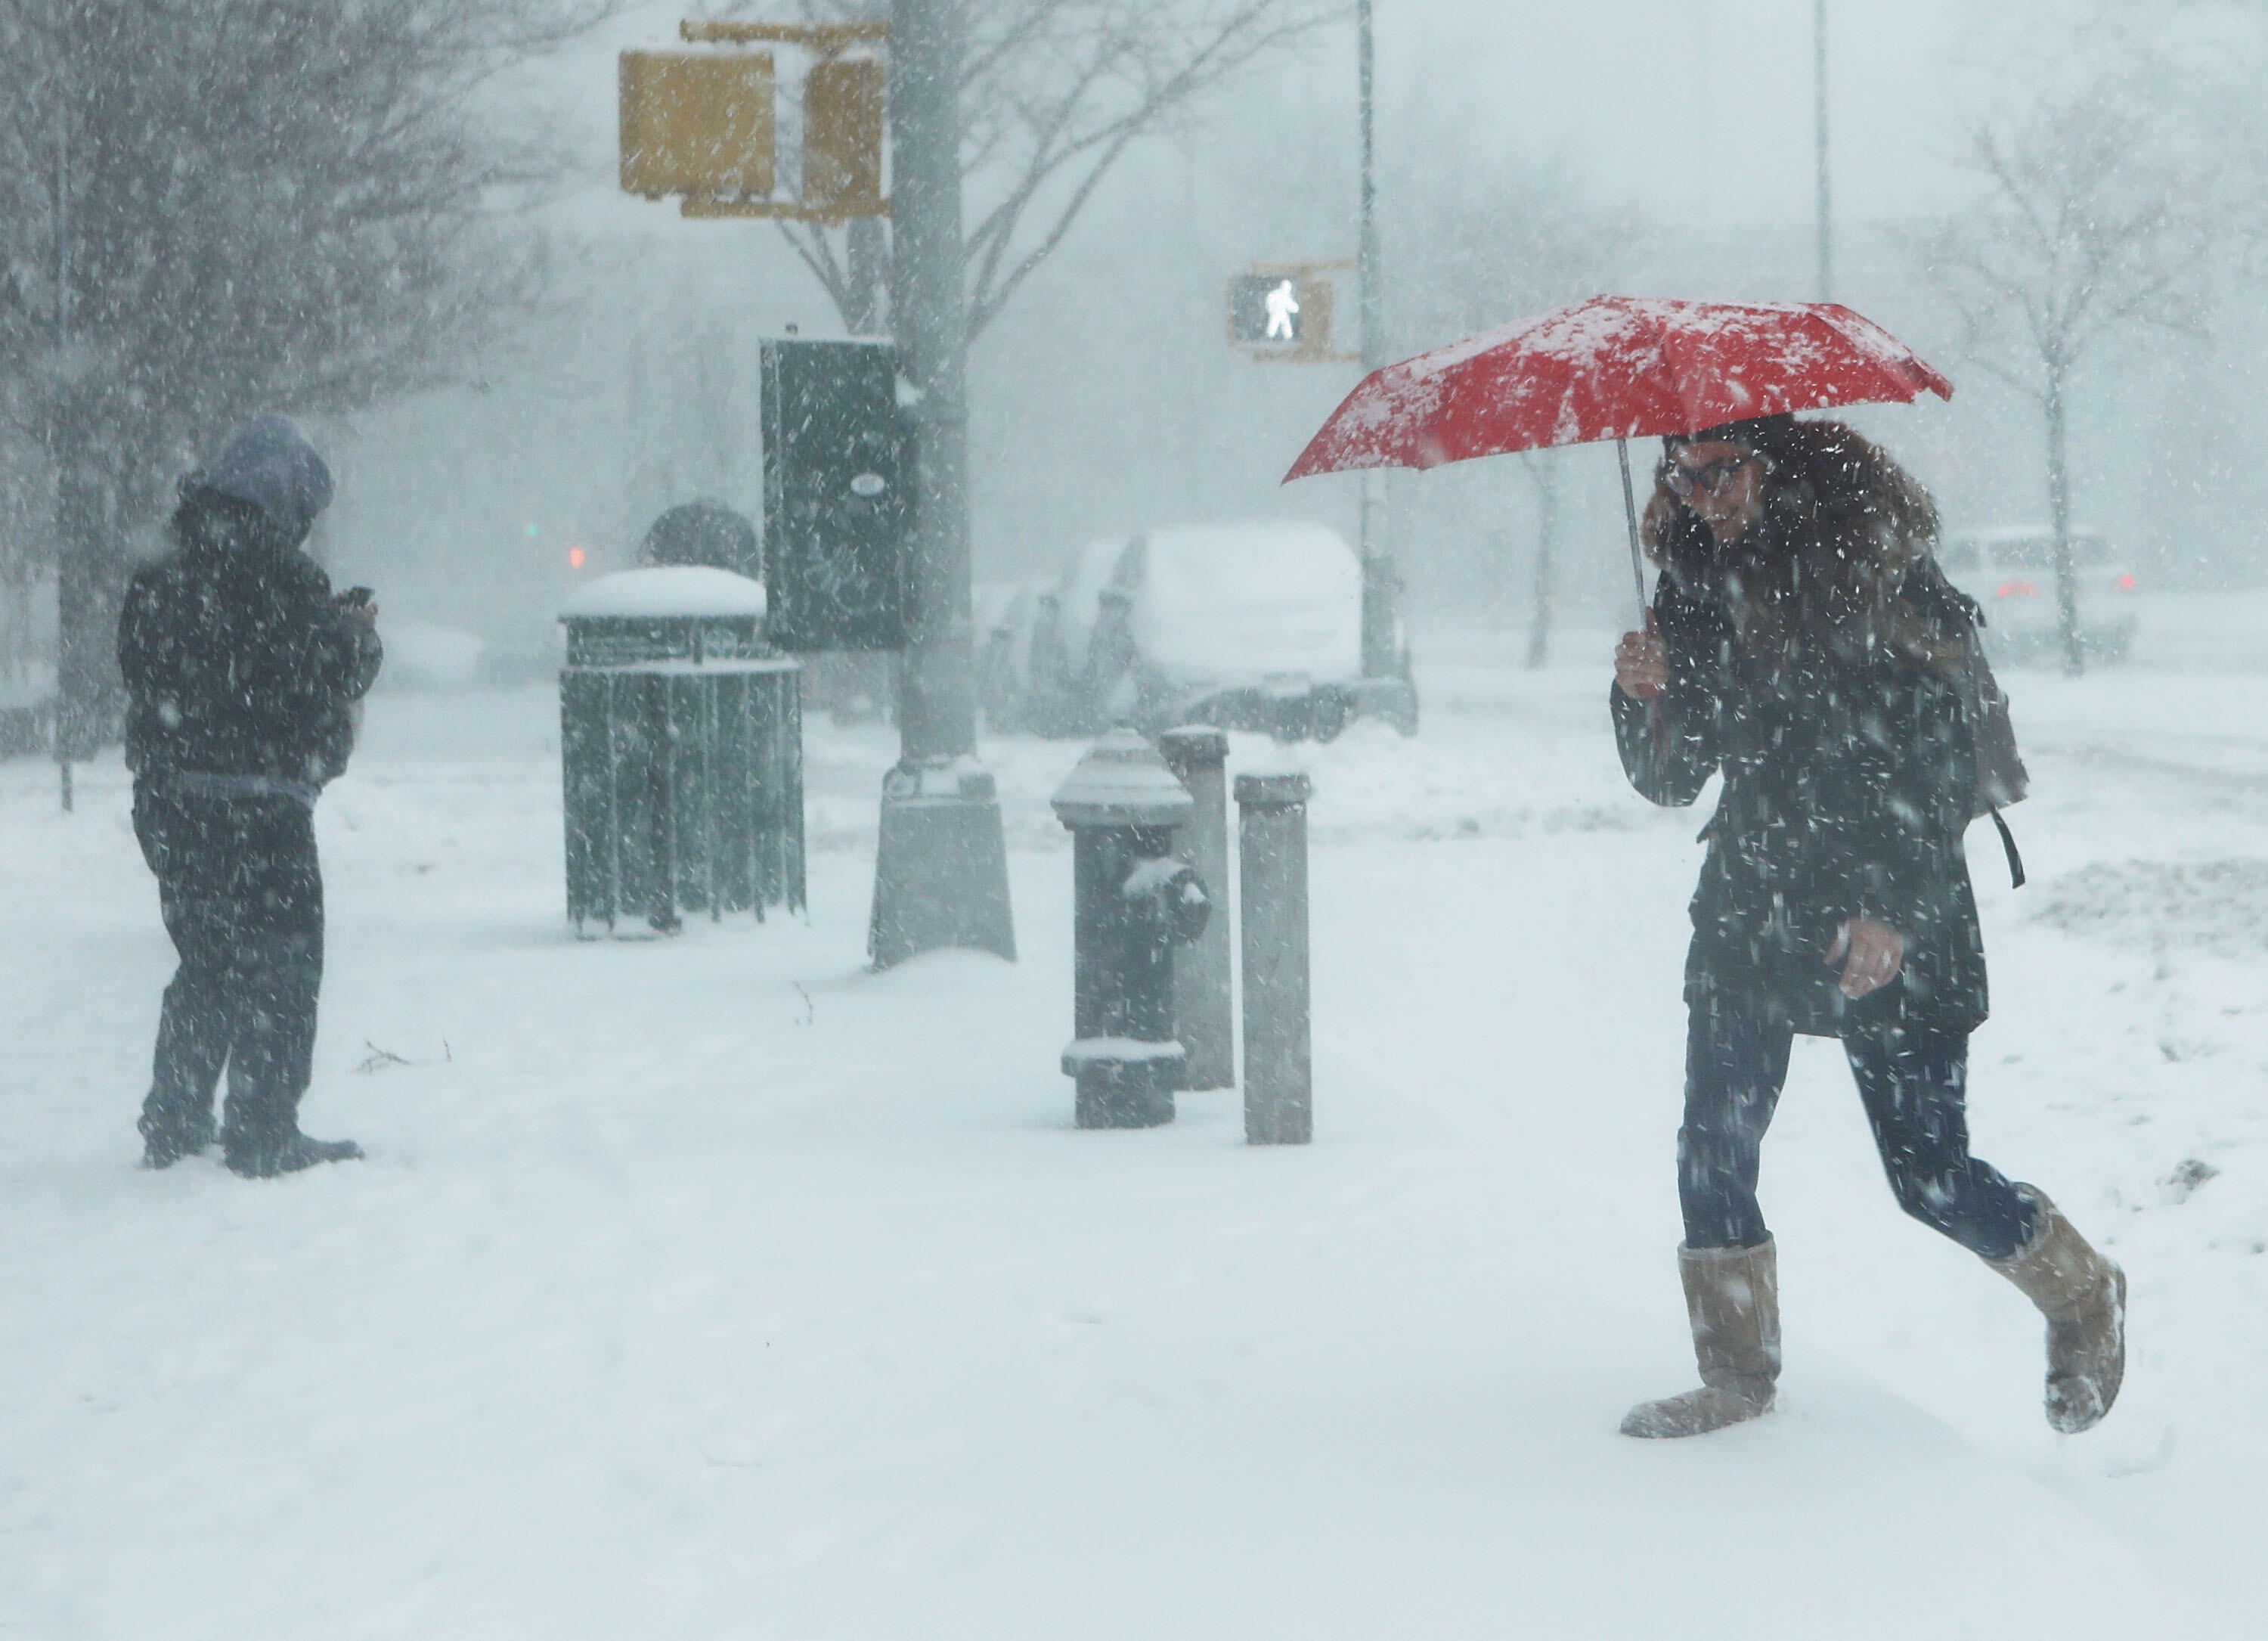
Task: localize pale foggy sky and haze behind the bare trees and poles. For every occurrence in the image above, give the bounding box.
[22,0,2263,690]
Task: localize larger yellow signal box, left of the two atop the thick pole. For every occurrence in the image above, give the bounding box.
[621,52,776,200]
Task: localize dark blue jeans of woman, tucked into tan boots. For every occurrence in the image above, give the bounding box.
[1678,1001,2032,1260]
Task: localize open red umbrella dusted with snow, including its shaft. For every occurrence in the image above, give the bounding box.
[1284,297,1953,603]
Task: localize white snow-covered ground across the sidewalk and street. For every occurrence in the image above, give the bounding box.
[0,601,2268,1641]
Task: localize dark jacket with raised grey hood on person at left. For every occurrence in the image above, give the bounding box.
[118,415,383,794]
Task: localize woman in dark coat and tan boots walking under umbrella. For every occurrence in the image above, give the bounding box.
[1613,415,2125,1437]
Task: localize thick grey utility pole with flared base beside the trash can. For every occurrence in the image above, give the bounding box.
[869,0,1016,969]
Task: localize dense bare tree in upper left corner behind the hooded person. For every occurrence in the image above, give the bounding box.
[0,0,624,746]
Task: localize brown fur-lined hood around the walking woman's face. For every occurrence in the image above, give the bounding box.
[1644,427,1957,672]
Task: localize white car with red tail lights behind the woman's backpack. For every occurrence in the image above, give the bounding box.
[1937,524,2141,662]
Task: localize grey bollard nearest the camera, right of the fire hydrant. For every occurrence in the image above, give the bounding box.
[1236,774,1315,1146]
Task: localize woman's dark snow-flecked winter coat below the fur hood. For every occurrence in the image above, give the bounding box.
[1613,533,1989,1038]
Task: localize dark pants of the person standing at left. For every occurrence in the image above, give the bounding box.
[134,780,322,1153]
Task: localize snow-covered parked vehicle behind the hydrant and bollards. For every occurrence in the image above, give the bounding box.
[991,524,1363,740]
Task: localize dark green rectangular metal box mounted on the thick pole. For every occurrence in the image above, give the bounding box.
[760,340,914,653]
